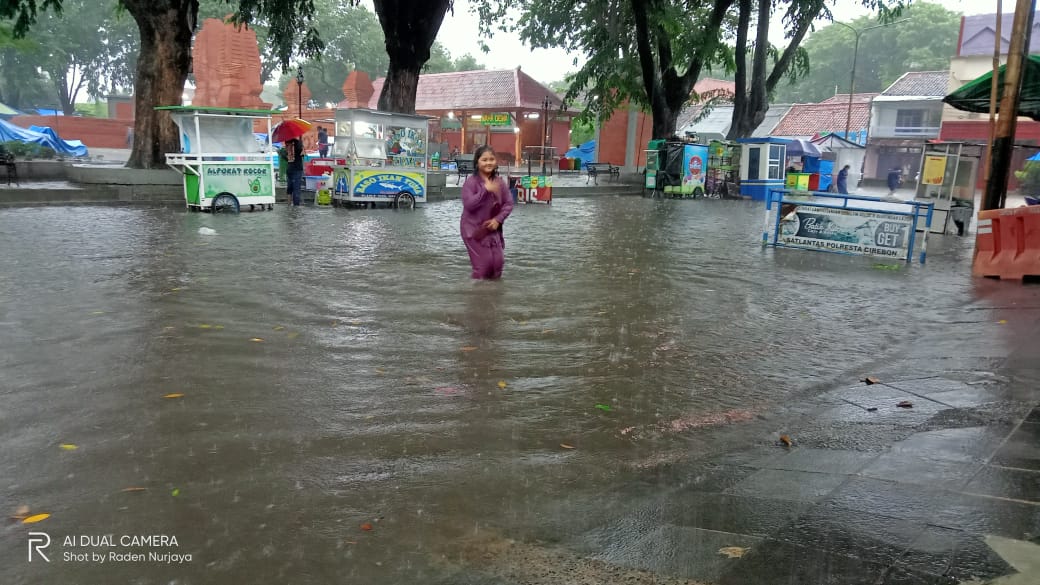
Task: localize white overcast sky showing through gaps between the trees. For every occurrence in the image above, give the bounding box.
[365,0,994,83]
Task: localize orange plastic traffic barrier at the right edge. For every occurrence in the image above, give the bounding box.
[971,206,1040,280]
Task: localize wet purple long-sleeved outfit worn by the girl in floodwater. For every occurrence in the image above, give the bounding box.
[459,175,513,279]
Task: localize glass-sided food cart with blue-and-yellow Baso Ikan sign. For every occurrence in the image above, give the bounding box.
[332,108,430,209]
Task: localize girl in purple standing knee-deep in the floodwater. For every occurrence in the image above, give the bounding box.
[460,145,513,279]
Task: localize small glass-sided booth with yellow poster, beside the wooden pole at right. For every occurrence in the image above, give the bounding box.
[914,143,976,233]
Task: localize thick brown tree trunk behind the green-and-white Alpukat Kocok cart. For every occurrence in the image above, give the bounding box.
[123,0,199,169]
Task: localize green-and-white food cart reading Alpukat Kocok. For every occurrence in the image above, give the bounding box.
[156,106,275,212]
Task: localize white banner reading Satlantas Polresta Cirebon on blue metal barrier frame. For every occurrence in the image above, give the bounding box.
[780,205,913,258]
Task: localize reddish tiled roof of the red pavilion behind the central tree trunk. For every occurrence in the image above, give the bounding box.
[361,68,573,112]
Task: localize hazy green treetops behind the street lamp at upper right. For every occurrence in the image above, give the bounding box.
[774,2,960,103]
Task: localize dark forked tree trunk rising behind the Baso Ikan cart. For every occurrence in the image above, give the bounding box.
[375,0,452,113]
